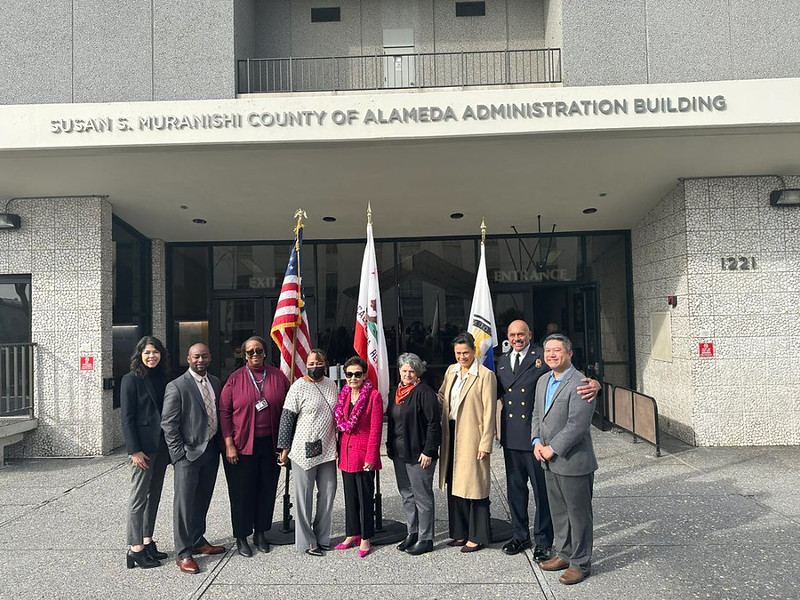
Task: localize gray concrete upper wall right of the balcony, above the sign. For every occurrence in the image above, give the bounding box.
[563,0,800,86]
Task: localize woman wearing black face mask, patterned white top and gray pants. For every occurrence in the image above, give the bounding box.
[278,348,338,556]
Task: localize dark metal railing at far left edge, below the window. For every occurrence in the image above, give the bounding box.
[0,344,36,418]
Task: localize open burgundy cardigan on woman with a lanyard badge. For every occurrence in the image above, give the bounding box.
[219,365,289,455]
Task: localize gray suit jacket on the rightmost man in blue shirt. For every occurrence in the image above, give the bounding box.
[531,368,597,475]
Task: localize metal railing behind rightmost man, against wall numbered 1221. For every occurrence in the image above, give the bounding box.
[603,383,661,456]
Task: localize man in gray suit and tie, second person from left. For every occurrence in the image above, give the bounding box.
[161,344,225,573]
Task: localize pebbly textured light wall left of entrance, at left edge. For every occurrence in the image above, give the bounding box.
[0,197,122,456]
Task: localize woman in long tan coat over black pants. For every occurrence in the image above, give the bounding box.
[439,332,497,552]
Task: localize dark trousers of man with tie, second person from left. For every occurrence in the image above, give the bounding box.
[172,440,219,558]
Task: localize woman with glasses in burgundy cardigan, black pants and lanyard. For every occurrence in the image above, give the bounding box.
[219,335,289,558]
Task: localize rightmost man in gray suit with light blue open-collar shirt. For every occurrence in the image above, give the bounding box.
[531,333,597,585]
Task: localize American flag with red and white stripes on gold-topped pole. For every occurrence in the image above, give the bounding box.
[270,222,311,382]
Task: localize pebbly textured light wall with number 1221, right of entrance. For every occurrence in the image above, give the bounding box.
[632,177,800,446]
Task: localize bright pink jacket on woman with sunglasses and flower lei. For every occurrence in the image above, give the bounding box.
[339,389,383,473]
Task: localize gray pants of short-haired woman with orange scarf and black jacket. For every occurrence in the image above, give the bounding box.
[394,459,436,540]
